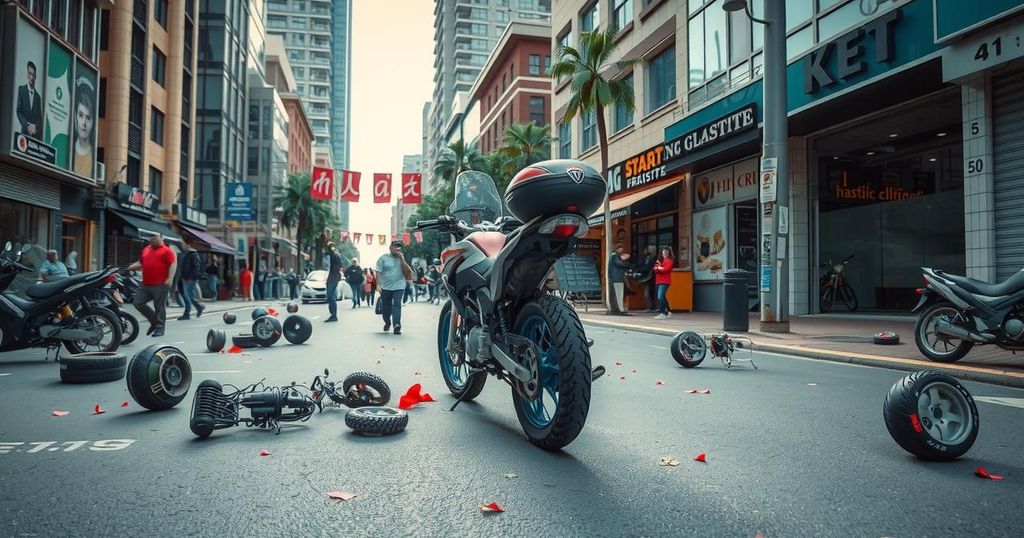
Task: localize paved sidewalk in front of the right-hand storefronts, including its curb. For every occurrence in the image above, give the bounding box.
[578,307,1024,388]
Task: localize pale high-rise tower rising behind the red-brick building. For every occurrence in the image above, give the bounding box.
[424,0,551,191]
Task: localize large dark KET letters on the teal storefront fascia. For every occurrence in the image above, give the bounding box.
[803,9,903,93]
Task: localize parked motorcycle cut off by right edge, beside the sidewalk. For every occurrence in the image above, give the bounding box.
[912,267,1024,363]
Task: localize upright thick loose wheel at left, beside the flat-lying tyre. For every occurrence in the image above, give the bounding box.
[127,343,191,411]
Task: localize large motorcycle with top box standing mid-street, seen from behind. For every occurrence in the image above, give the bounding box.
[417,160,606,450]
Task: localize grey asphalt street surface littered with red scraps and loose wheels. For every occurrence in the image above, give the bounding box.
[0,304,1024,538]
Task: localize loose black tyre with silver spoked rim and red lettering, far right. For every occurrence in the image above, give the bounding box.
[882,370,980,461]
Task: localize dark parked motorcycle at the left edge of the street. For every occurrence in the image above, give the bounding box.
[0,241,121,354]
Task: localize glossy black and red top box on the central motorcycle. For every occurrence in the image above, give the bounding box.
[505,159,607,222]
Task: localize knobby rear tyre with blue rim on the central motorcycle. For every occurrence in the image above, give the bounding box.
[512,295,592,450]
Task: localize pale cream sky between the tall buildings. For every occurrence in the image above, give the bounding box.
[349,0,434,265]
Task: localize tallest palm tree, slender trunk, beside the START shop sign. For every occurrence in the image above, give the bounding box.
[551,24,642,314]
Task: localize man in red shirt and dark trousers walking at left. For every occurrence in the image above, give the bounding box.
[128,234,178,336]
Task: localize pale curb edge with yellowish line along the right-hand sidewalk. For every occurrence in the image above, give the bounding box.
[581,318,1024,388]
